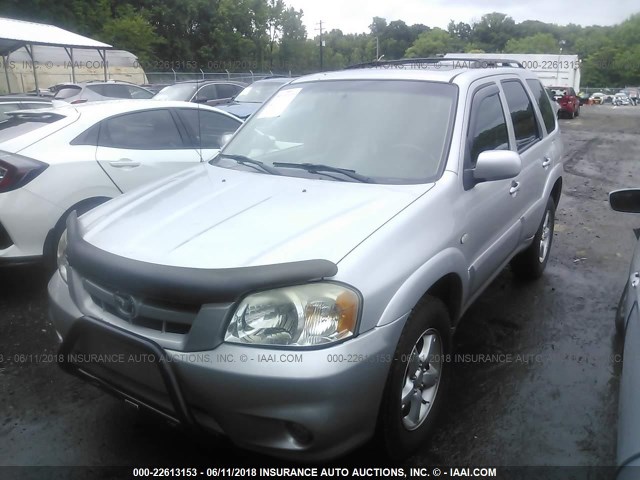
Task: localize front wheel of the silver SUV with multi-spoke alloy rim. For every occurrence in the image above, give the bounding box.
[380,296,451,459]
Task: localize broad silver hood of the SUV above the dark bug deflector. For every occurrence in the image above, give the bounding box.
[80,164,433,268]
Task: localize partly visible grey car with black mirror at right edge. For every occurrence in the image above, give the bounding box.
[609,189,640,480]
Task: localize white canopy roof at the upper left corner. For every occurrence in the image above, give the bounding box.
[0,18,113,56]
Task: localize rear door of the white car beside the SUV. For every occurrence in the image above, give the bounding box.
[96,108,200,192]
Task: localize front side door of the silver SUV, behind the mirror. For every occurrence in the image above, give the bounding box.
[460,82,523,295]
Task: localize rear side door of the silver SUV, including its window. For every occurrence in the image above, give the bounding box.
[501,78,551,241]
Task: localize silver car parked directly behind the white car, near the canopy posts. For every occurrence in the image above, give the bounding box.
[51,80,153,104]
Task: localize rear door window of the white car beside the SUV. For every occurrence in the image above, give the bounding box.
[98,110,184,150]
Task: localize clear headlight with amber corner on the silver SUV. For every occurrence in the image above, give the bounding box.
[224,283,360,347]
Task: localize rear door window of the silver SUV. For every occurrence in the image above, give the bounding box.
[502,80,542,152]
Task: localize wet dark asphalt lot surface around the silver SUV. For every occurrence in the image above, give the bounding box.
[0,105,640,478]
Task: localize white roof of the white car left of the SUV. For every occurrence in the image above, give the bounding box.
[9,99,245,120]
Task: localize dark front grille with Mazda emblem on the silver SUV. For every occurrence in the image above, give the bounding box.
[83,279,200,335]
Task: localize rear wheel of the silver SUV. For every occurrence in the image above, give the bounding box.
[511,197,556,280]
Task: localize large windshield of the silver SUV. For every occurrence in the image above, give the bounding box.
[218,80,457,183]
